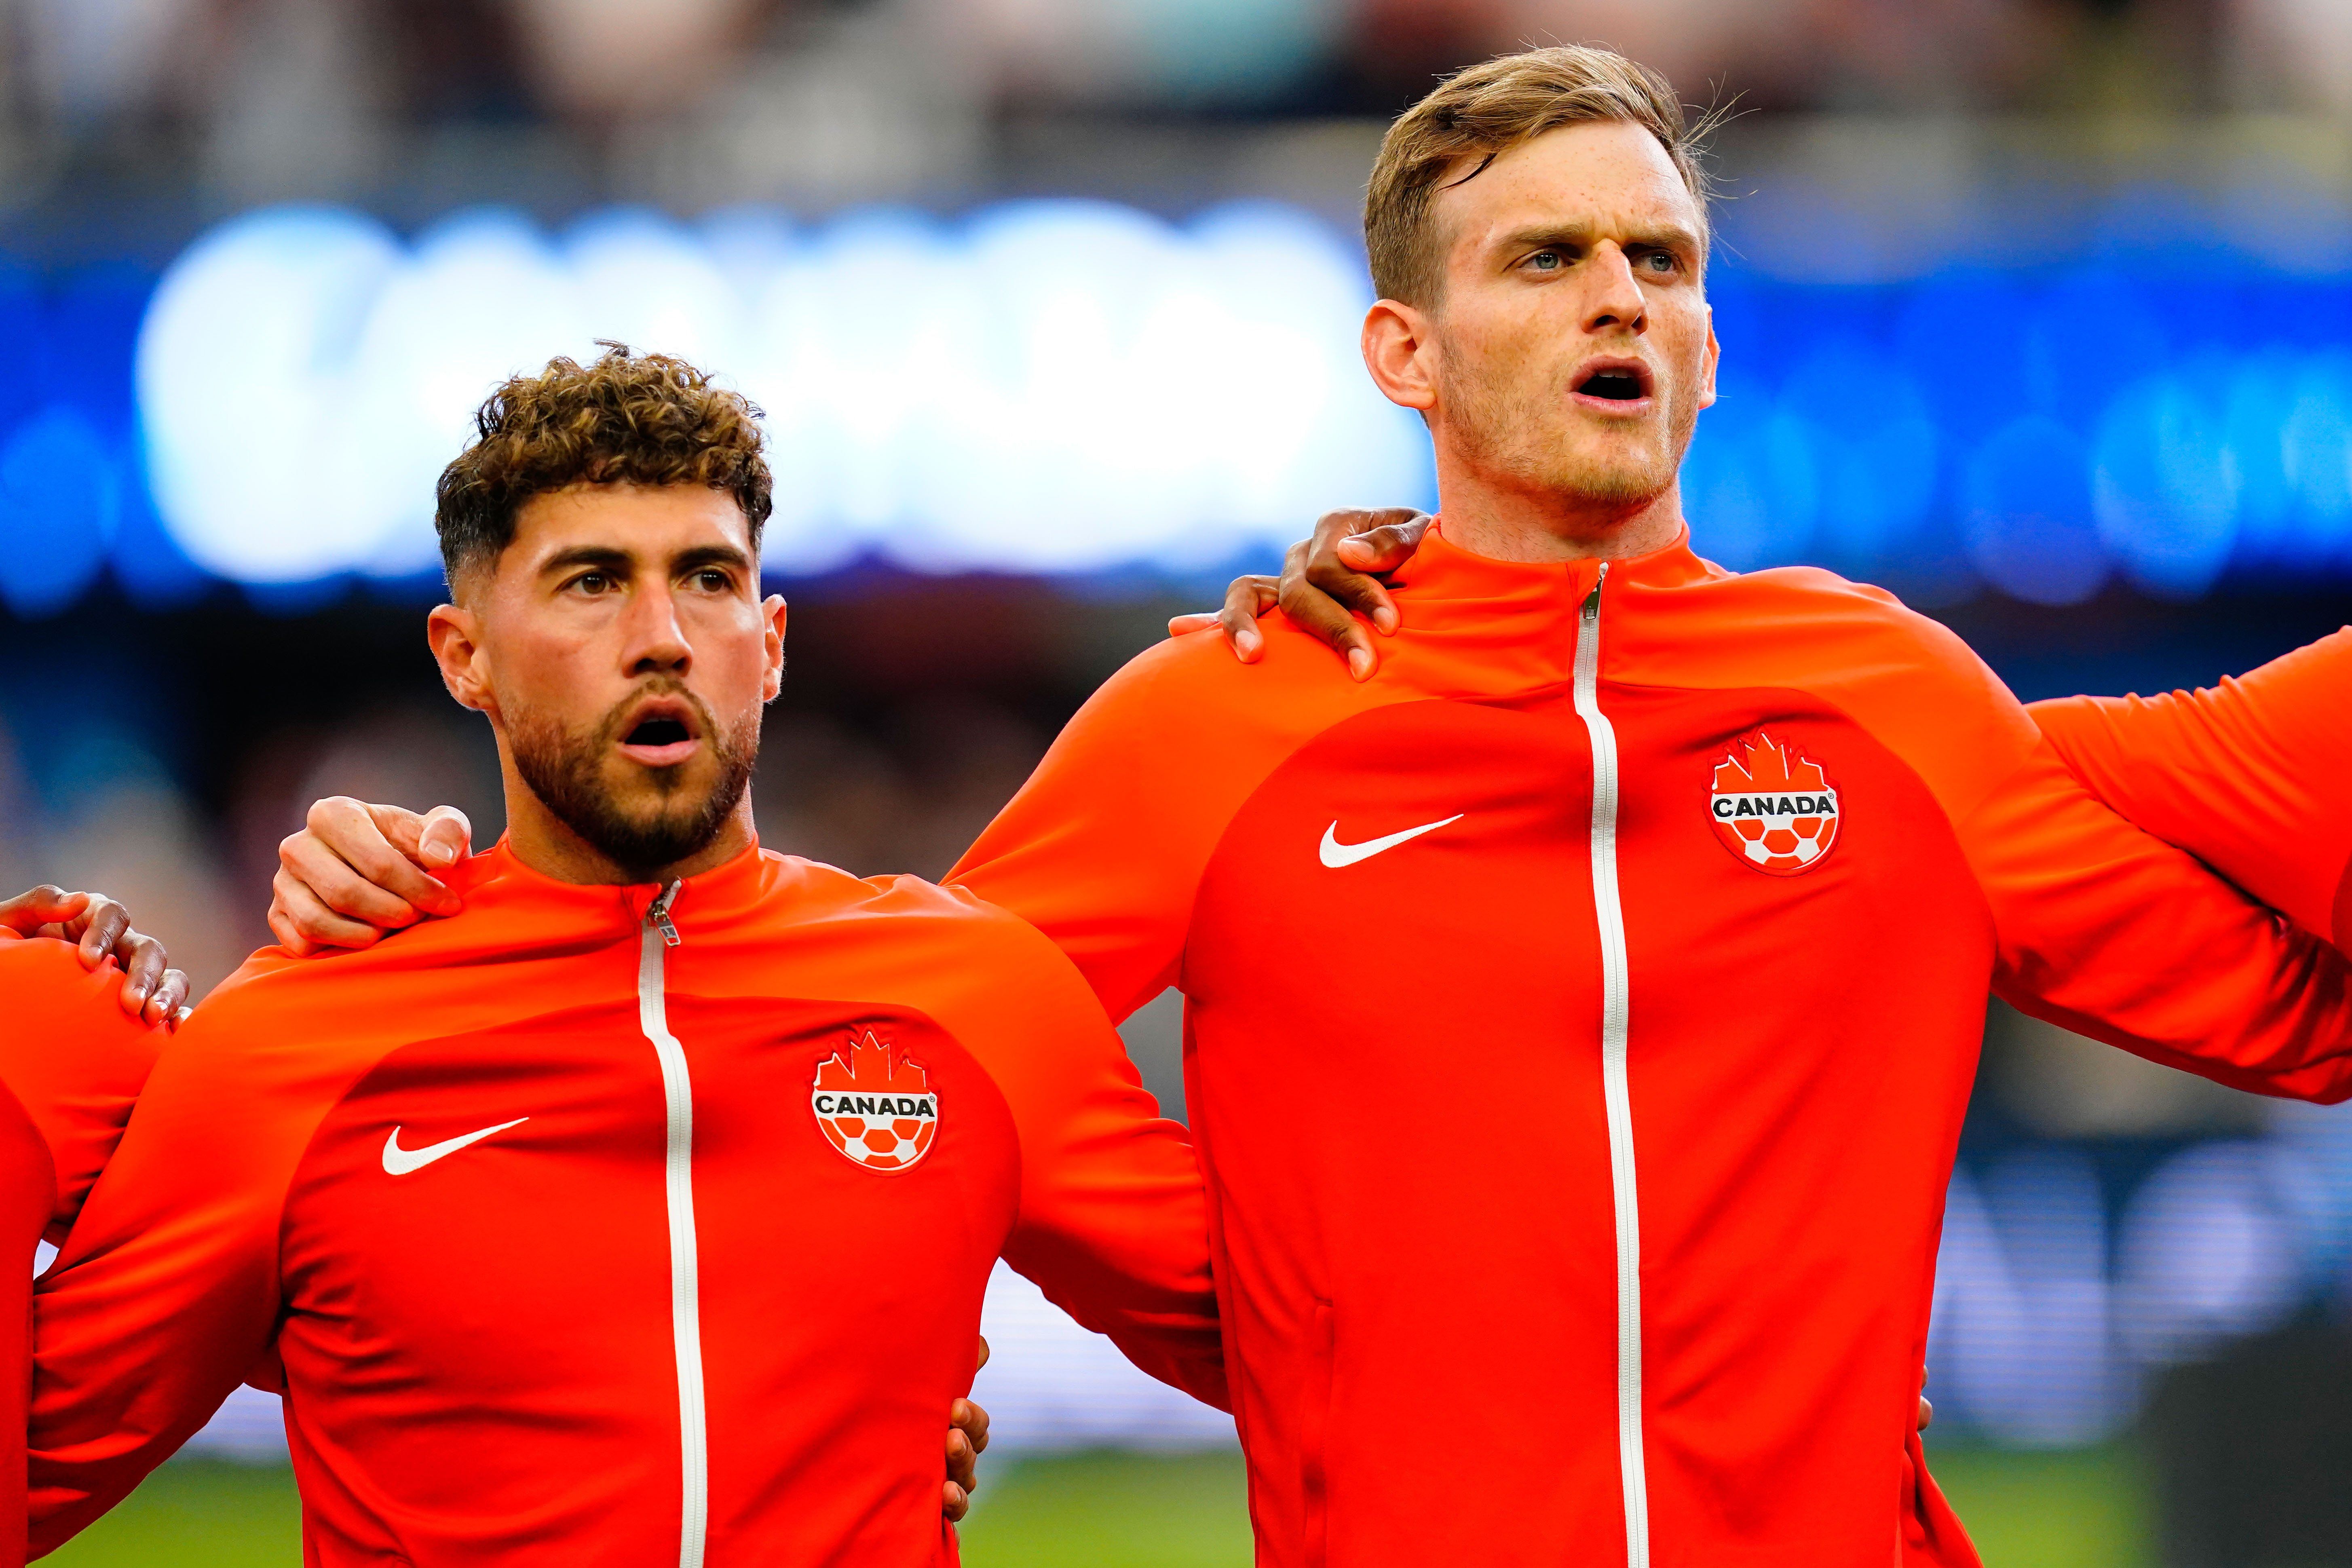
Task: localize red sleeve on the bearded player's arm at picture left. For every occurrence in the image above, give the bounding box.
[28,973,301,1554]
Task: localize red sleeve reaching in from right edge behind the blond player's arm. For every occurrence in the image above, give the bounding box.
[2030,628,2352,952]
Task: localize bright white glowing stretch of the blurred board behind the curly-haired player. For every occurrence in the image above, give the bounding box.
[139,202,1428,580]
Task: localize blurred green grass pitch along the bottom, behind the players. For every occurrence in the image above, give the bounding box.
[49,1448,2154,1568]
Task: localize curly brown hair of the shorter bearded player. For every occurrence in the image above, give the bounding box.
[433,338,774,593]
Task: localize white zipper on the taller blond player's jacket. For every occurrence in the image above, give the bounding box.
[1576,562,1649,1568]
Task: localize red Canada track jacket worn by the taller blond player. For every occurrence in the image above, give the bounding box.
[955,529,2352,1568]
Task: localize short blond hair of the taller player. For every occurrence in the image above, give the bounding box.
[1364,44,1717,308]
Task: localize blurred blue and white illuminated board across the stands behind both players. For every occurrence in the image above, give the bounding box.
[0,193,2352,614]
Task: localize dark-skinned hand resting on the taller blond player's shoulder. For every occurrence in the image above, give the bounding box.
[1169,505,1430,680]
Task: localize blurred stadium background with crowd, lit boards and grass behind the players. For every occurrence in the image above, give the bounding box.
[0,0,2352,1568]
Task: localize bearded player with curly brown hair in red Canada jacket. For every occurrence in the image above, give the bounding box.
[31,348,1225,1568]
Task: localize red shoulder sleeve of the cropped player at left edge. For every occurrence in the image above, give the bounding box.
[0,933,165,1243]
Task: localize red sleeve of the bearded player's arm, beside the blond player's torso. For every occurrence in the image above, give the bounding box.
[952,914,1233,1410]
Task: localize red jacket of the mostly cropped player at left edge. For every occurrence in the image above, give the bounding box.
[0,931,162,1568]
